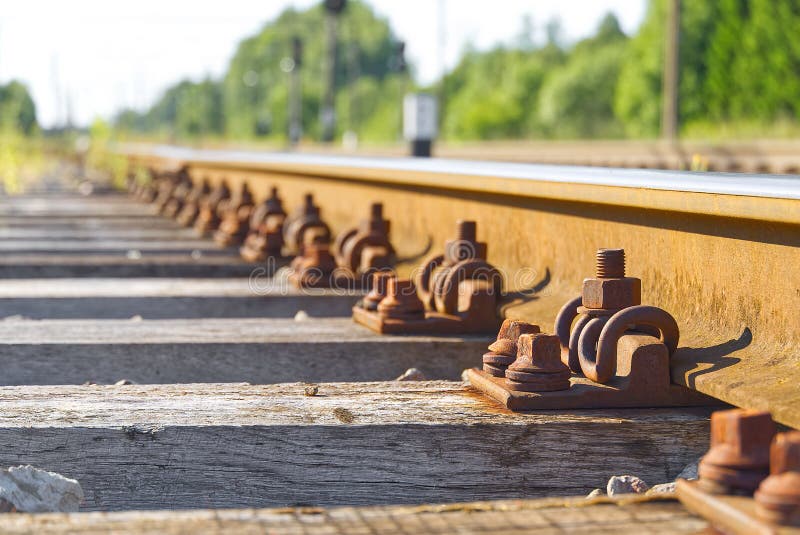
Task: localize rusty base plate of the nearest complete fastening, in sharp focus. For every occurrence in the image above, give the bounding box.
[467,368,720,411]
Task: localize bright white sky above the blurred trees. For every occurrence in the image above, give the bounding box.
[0,0,646,127]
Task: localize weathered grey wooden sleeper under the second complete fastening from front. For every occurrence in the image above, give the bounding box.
[0,318,490,385]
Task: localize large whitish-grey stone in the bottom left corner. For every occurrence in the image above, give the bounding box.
[0,465,83,513]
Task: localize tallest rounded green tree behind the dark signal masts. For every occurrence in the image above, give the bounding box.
[223,1,400,138]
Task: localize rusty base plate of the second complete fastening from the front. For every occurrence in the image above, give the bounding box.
[353,306,497,335]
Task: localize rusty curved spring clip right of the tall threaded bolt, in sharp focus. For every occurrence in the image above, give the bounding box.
[576,305,680,383]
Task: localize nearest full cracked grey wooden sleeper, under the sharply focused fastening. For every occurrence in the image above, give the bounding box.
[0,381,708,510]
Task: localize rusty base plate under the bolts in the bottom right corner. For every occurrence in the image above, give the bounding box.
[677,479,800,535]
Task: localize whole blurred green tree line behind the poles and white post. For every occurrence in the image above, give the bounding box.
[115,0,800,142]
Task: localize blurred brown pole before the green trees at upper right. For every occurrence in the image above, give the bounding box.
[661,0,681,142]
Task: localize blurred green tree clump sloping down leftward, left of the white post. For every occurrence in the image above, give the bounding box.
[115,1,410,141]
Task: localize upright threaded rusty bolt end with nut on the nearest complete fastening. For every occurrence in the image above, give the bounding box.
[582,249,642,310]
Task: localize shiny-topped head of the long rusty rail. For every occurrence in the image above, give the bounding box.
[119,145,800,224]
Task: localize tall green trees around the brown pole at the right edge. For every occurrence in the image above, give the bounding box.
[615,0,800,136]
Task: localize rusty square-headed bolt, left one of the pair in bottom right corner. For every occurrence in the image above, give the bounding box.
[698,409,776,495]
